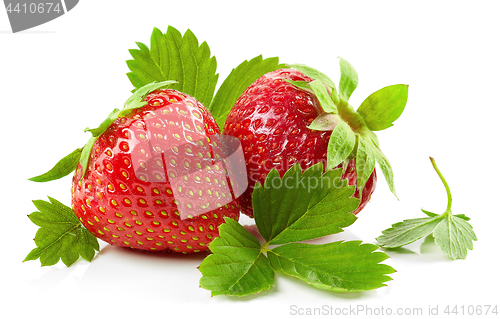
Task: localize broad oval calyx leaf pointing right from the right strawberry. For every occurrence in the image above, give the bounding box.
[357,84,408,131]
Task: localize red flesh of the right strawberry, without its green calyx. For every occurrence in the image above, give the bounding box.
[224,69,377,217]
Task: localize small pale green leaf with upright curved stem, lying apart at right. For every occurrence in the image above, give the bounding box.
[377,157,477,259]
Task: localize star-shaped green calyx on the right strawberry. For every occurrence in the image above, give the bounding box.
[287,58,408,197]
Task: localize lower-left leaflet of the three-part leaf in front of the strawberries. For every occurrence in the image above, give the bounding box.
[199,218,274,296]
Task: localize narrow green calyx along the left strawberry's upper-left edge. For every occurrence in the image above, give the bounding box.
[29,81,177,182]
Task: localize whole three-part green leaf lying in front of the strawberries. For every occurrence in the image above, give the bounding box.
[199,163,394,296]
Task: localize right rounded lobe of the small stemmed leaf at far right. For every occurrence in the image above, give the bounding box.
[434,215,477,260]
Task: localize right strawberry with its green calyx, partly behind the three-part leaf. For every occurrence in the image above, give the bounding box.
[224,59,407,217]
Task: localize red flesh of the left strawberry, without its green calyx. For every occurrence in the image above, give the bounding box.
[72,89,239,253]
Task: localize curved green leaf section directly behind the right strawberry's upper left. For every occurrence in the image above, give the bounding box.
[209,55,282,130]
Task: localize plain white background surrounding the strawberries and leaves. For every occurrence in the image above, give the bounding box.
[0,0,500,318]
